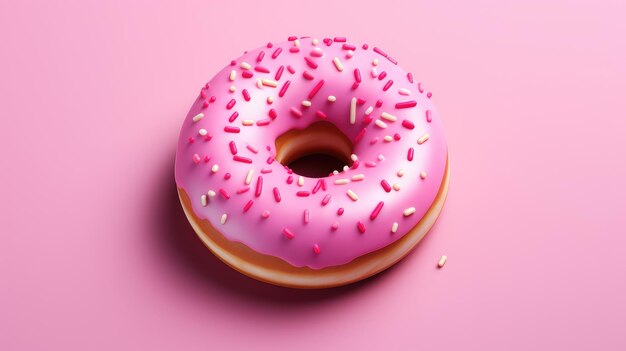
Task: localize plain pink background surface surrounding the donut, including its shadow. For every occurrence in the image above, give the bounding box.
[0,0,626,351]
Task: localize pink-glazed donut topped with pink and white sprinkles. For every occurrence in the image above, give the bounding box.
[175,36,449,288]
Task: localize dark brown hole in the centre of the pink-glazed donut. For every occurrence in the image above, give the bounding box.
[276,121,354,178]
